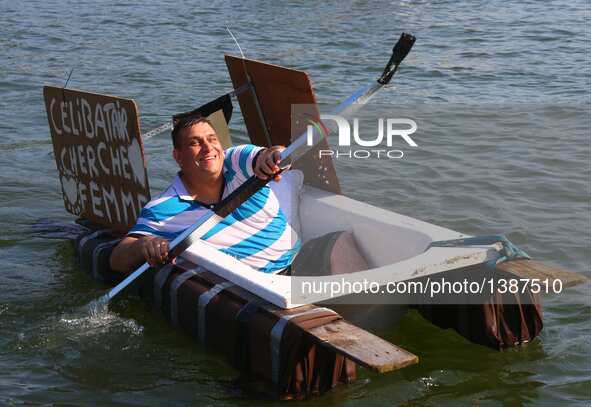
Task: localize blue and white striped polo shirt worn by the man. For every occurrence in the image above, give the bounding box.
[128,144,300,273]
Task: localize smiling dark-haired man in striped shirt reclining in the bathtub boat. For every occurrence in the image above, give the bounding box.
[110,117,300,273]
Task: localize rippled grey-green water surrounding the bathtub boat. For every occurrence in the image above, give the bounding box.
[0,0,591,407]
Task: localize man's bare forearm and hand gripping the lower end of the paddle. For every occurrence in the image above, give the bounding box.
[109,236,168,272]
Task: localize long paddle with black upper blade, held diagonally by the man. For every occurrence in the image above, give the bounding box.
[98,33,415,304]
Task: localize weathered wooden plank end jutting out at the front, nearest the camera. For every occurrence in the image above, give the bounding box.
[308,320,419,373]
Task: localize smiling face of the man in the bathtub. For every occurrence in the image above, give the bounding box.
[173,122,224,178]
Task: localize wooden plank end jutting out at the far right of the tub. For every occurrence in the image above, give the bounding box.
[497,260,589,287]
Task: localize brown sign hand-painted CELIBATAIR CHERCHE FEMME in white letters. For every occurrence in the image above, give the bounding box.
[43,86,150,231]
